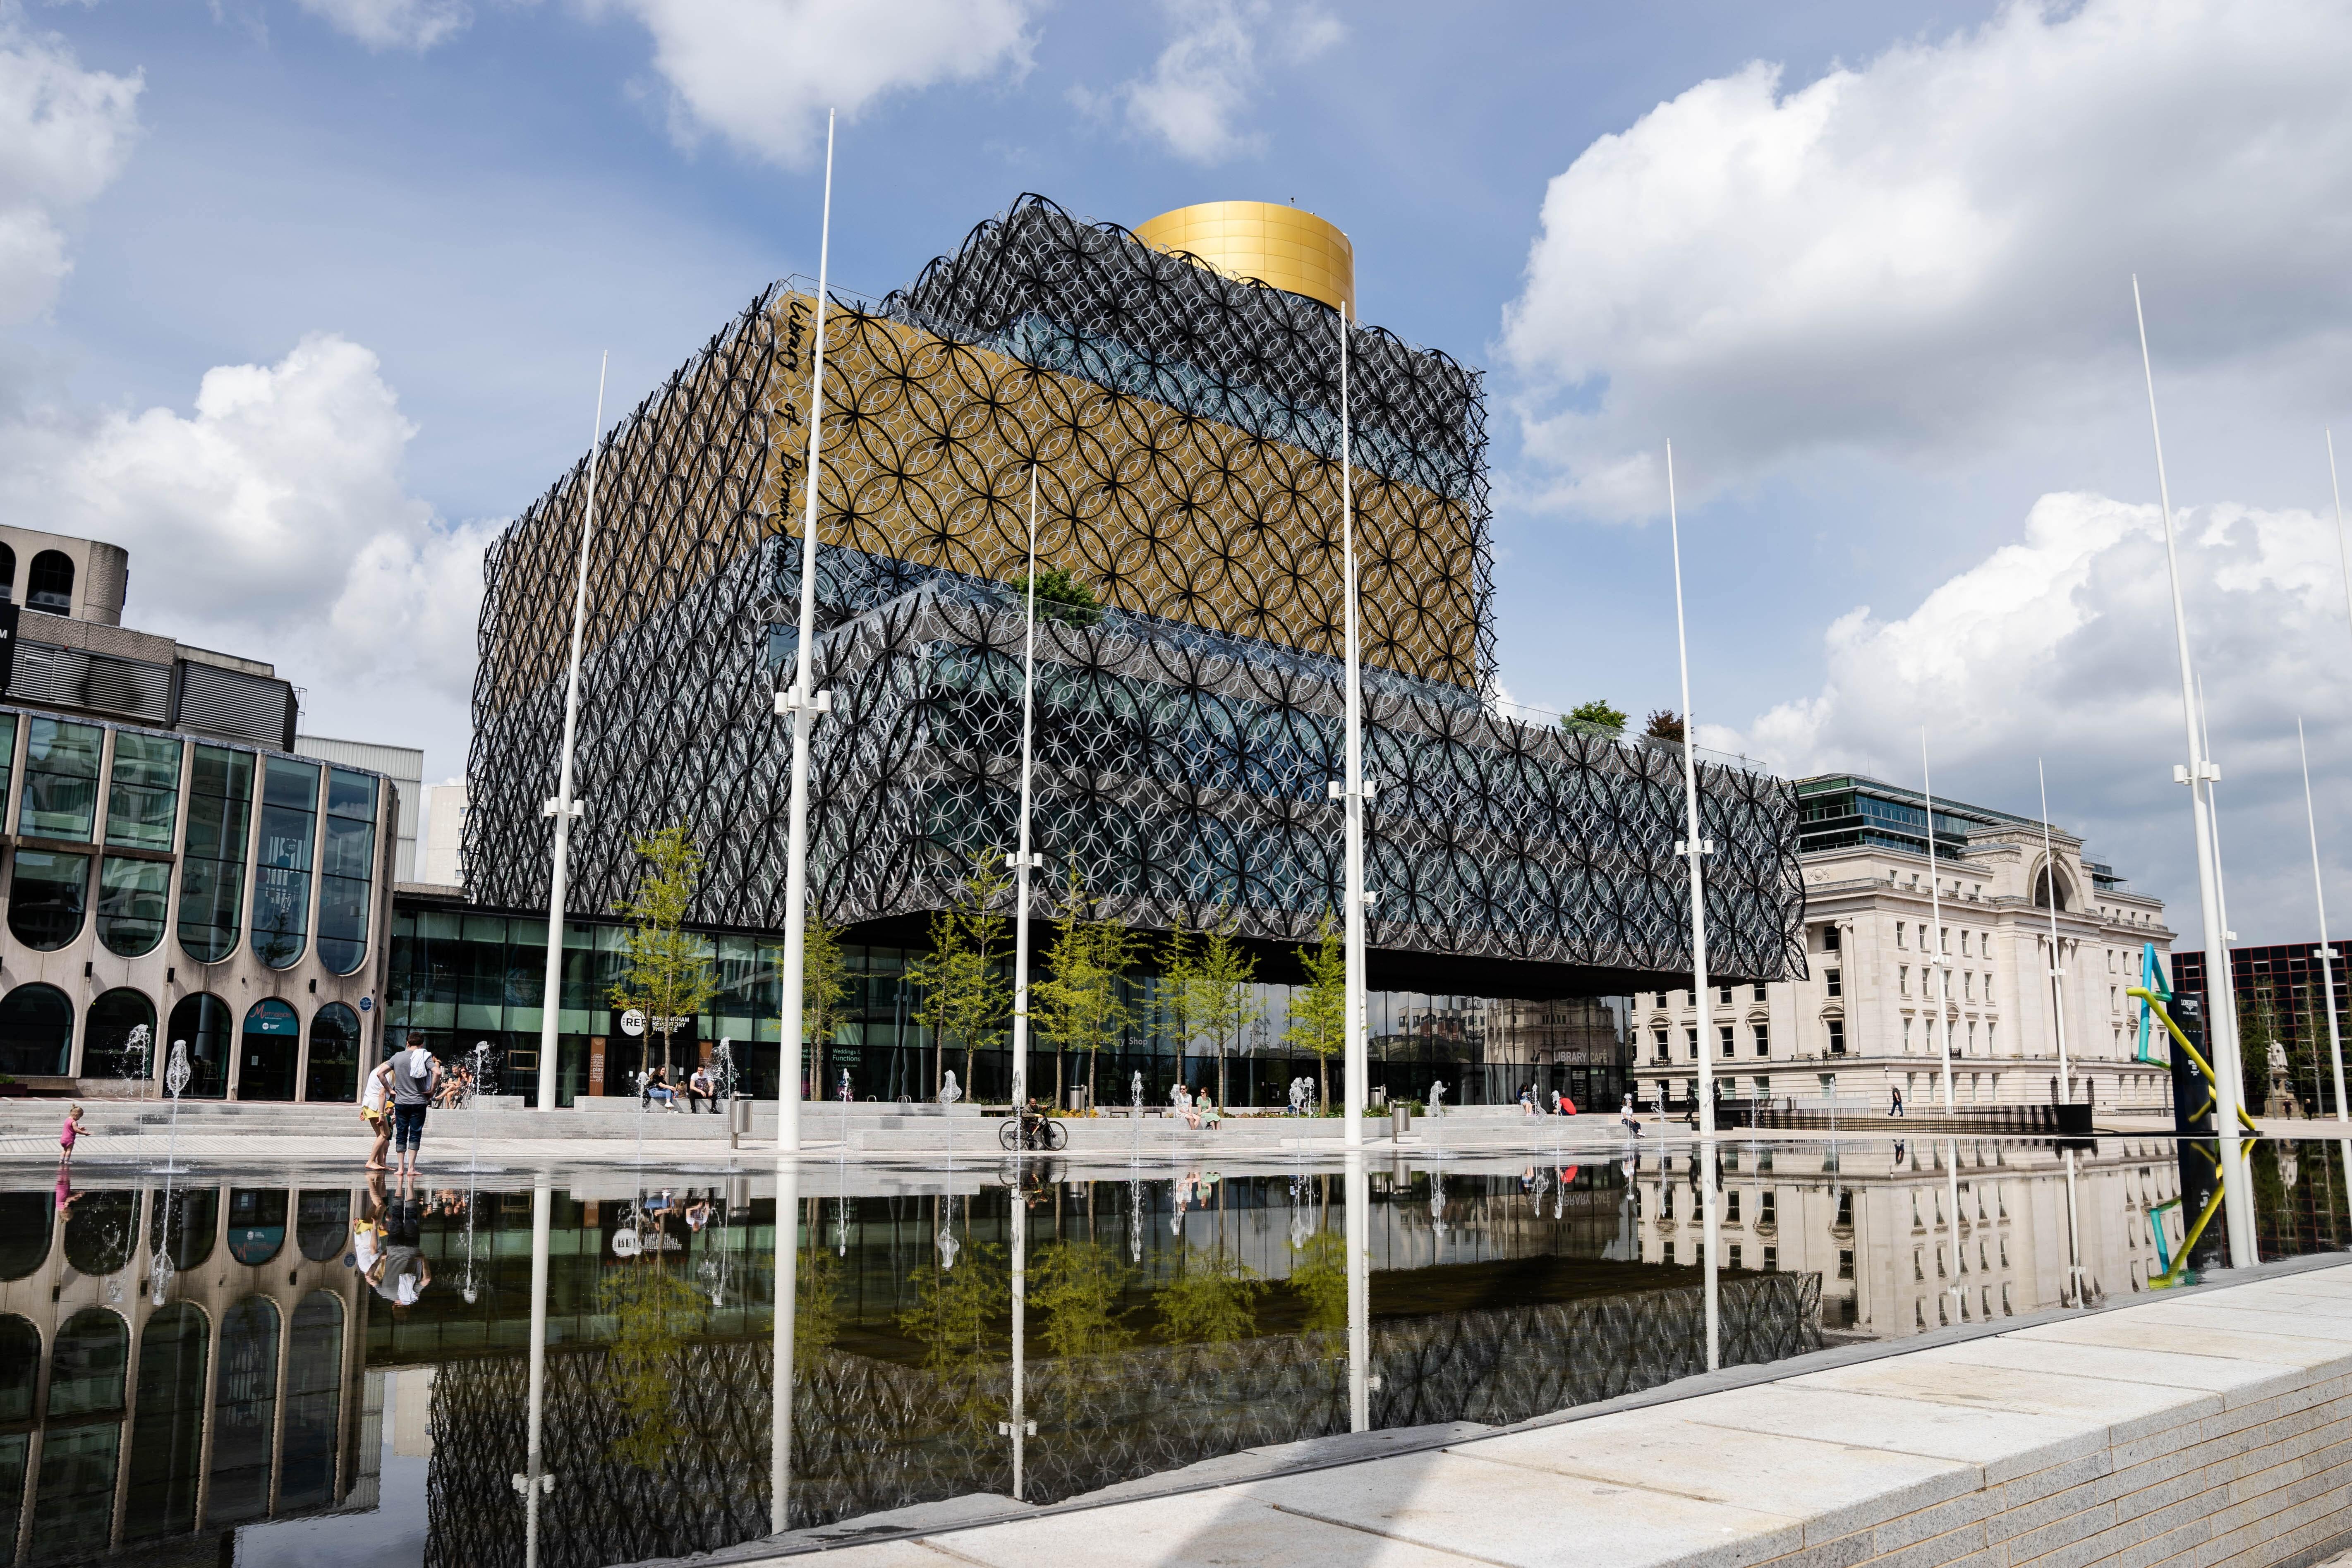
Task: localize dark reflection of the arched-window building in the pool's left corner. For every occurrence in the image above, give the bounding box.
[0,1185,378,1563]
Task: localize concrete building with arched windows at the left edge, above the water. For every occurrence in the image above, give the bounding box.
[0,527,400,1100]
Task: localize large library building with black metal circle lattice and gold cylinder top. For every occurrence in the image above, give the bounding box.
[444,197,1804,1093]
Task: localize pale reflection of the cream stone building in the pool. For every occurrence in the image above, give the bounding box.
[1637,1138,2183,1340]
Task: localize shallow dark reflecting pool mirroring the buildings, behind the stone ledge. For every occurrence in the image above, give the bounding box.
[0,1138,2352,1568]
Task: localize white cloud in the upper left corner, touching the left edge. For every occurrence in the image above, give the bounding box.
[0,5,144,324]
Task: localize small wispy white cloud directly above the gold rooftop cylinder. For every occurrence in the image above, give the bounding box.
[1073,0,1345,165]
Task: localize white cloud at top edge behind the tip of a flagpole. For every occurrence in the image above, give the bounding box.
[600,0,1039,165]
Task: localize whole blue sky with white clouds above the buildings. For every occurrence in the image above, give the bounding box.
[0,0,2352,943]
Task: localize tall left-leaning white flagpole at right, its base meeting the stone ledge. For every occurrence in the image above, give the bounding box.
[2131,278,2256,1267]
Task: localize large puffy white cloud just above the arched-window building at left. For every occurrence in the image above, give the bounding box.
[0,334,503,743]
